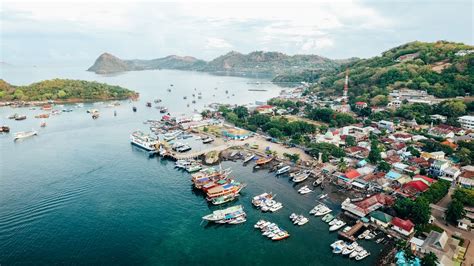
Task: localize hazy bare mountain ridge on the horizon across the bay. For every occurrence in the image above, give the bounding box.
[88,51,340,77]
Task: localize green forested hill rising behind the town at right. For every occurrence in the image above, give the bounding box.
[276,41,474,98]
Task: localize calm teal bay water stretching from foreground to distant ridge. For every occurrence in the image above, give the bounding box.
[0,65,381,265]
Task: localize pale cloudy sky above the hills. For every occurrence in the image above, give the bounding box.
[0,0,474,65]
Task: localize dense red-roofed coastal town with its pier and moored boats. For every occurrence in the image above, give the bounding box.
[118,59,474,265]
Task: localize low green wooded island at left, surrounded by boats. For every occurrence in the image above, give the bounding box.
[0,79,138,103]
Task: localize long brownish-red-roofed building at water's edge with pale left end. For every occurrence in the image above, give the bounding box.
[341,193,395,217]
